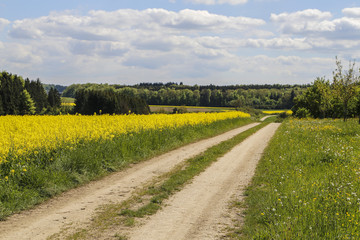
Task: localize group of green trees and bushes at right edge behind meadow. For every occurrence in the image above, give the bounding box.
[292,58,360,123]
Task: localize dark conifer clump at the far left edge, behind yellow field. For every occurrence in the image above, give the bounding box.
[0,71,61,115]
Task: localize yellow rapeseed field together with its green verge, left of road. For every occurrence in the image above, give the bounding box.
[0,112,251,218]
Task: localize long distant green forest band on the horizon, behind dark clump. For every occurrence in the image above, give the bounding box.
[63,83,307,109]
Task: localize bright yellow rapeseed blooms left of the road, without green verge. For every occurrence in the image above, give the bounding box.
[0,112,250,164]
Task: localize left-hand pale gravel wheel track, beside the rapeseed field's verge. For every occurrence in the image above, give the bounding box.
[0,123,258,240]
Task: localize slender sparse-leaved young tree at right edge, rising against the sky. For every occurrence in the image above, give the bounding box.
[332,58,360,121]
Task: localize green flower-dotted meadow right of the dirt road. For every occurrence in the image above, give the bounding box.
[237,120,360,239]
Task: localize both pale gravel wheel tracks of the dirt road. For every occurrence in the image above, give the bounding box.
[0,123,262,240]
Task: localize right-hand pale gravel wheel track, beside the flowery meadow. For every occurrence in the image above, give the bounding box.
[130,123,279,240]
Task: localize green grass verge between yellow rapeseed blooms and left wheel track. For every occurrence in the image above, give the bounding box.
[0,119,251,220]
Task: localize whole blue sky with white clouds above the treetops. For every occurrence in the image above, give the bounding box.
[0,0,360,85]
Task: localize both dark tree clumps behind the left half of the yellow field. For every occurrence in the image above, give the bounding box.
[0,71,150,115]
